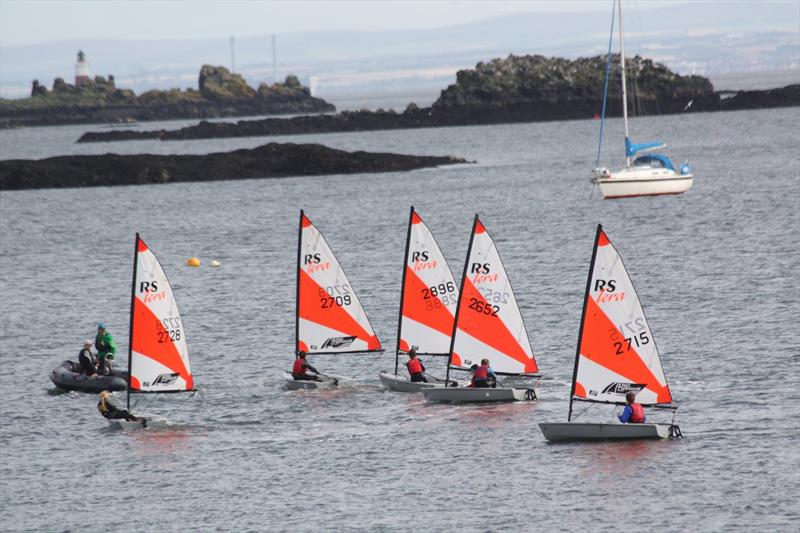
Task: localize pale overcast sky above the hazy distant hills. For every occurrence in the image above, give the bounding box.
[0,0,688,46]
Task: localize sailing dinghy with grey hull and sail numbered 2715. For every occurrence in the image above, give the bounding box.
[539,224,681,441]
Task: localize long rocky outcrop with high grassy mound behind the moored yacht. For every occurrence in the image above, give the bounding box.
[78,56,800,142]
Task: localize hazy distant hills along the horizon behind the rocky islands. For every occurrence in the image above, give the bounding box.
[0,2,800,103]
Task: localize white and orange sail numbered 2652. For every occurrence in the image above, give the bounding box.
[451,215,539,374]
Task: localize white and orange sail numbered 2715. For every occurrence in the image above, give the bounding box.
[570,225,672,411]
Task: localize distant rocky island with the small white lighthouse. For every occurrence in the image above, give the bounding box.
[0,65,336,128]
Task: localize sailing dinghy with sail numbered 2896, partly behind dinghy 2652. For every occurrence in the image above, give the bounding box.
[379,206,465,392]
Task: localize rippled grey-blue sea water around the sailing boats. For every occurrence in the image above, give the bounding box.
[0,108,800,531]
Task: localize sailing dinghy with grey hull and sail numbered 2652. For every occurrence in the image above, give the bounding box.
[422,215,539,403]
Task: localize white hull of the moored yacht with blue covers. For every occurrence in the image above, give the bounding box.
[592,167,694,199]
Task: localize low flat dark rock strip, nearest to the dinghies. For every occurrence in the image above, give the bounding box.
[0,143,466,191]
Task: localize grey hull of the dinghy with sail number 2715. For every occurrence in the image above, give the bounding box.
[539,422,681,442]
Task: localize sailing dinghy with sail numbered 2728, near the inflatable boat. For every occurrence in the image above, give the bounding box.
[108,233,195,429]
